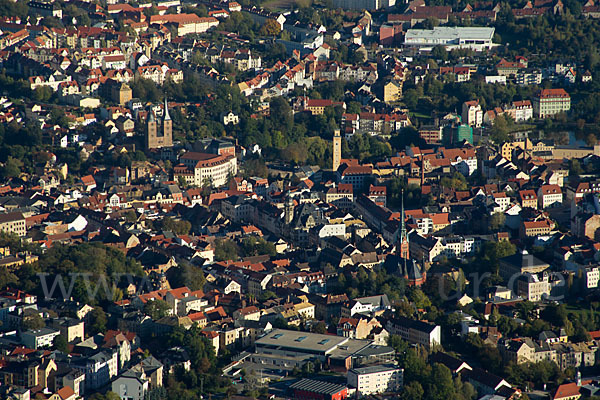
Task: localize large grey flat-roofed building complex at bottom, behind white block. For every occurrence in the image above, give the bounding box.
[252,329,394,369]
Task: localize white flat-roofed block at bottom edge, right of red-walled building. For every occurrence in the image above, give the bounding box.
[347,364,404,397]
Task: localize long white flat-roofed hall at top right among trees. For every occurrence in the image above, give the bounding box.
[404,26,494,51]
